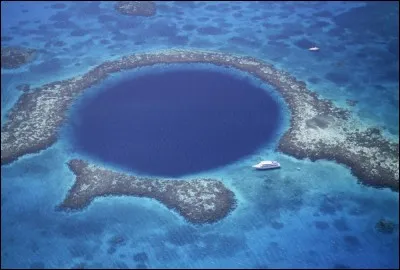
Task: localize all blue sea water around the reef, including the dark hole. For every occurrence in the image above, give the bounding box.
[1,1,399,269]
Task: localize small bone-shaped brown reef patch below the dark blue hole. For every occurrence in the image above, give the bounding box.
[59,159,236,223]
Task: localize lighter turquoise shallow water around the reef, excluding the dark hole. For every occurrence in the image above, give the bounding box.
[1,2,399,268]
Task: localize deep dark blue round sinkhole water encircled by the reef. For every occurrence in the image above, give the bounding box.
[72,69,281,177]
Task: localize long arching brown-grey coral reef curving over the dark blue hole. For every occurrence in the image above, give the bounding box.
[1,50,399,191]
